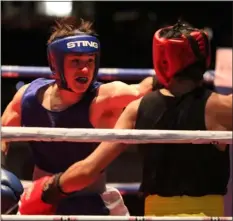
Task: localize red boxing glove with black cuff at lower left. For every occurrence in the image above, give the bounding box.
[19,174,67,215]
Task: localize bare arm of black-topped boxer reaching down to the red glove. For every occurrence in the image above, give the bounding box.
[60,99,140,192]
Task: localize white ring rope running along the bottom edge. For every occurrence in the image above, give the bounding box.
[1,215,232,221]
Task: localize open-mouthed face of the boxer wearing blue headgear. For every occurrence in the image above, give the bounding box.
[64,54,95,93]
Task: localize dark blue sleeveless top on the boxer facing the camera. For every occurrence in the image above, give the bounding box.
[21,78,101,173]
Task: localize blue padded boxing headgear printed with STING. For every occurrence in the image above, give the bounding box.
[47,34,100,91]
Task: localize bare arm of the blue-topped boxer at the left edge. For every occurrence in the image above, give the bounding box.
[1,84,29,154]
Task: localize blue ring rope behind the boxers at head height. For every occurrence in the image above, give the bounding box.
[1,65,215,82]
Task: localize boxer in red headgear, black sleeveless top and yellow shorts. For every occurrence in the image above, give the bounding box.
[42,19,232,216]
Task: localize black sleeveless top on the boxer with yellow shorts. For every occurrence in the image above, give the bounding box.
[135,87,230,196]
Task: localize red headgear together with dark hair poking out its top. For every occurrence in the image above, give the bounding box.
[153,22,210,87]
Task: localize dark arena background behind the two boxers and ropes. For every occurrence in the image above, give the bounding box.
[1,1,232,215]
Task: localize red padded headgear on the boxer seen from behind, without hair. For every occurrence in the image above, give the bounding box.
[153,27,210,87]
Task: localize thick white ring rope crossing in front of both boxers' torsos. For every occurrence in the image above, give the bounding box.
[1,127,232,144]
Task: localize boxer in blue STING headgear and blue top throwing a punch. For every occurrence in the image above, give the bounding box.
[2,19,155,215]
